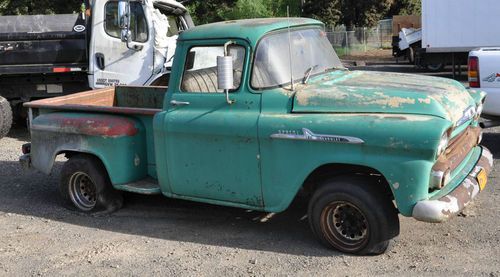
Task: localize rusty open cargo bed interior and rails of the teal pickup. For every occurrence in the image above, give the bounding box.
[24,86,167,115]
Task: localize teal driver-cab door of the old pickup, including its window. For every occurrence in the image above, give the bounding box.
[163,41,263,207]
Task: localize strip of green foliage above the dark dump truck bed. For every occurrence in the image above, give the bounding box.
[0,0,82,15]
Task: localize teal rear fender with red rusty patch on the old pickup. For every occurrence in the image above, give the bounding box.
[31,112,147,185]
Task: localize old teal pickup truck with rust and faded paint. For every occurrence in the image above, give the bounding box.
[20,18,493,254]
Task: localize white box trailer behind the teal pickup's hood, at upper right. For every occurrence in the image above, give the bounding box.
[393,0,500,75]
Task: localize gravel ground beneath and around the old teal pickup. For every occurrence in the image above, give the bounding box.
[0,59,500,276]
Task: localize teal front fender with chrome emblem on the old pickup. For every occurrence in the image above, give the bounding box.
[259,111,451,216]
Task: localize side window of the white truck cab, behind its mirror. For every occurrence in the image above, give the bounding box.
[104,1,148,42]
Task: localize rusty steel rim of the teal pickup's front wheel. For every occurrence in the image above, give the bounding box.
[321,201,369,251]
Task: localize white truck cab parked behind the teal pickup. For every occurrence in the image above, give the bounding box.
[89,0,194,88]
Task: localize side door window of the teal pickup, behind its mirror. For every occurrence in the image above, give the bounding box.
[181,46,245,93]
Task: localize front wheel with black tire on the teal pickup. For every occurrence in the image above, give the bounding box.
[308,177,399,255]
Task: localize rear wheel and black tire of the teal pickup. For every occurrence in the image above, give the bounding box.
[59,154,123,214]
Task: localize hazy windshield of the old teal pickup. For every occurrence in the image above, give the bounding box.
[252,28,344,89]
